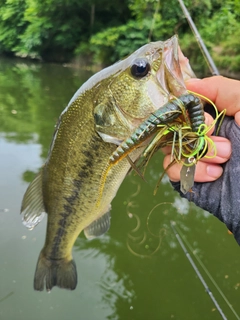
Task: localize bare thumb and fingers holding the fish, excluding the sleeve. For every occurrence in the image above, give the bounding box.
[163,76,240,182]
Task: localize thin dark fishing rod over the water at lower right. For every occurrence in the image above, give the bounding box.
[170,221,227,320]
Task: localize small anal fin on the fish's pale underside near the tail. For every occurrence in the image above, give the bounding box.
[84,211,111,239]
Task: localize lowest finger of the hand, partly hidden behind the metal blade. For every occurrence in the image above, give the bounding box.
[163,155,223,182]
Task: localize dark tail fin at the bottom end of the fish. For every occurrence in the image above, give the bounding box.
[34,252,77,291]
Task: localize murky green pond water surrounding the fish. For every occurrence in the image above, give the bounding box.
[0,59,240,320]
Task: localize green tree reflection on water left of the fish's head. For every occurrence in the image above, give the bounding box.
[0,59,91,150]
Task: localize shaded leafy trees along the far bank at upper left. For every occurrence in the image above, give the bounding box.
[0,0,129,61]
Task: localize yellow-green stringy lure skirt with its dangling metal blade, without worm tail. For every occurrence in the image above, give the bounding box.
[148,91,226,194]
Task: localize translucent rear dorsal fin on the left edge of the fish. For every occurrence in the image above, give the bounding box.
[21,172,45,229]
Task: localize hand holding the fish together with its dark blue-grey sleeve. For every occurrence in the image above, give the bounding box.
[164,76,240,245]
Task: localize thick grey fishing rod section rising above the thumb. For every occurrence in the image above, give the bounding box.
[178,0,220,76]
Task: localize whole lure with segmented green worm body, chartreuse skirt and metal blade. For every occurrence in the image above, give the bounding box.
[100,92,225,200]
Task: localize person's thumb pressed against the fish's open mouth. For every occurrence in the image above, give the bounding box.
[186,76,240,116]
